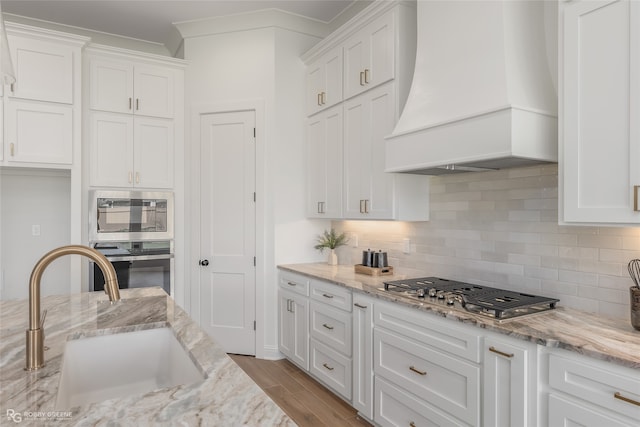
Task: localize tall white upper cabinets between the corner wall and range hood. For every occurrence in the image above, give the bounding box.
[303,1,429,221]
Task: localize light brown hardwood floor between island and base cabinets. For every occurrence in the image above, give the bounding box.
[229,354,370,427]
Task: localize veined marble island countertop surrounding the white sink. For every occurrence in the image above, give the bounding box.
[0,288,295,426]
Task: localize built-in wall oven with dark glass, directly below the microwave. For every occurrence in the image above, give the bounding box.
[89,240,174,295]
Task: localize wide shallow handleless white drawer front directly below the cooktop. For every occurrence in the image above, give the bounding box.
[374,302,482,363]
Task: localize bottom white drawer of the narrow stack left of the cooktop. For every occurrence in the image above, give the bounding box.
[309,339,352,400]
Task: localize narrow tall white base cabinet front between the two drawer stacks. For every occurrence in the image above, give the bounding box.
[351,292,375,420]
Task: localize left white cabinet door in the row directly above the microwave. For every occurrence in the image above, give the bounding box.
[90,112,133,187]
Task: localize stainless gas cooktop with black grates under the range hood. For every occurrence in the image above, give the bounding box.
[384,277,559,319]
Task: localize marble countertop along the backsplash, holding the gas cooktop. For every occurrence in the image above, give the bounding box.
[278,263,640,369]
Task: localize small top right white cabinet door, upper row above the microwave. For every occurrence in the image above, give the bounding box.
[133,65,174,118]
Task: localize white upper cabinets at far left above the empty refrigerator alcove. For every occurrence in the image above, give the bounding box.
[0,23,88,169]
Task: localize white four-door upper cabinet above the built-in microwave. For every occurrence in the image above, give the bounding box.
[85,46,184,189]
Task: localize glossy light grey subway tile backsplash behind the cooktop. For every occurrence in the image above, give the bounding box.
[332,165,640,319]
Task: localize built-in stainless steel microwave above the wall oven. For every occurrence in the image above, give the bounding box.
[89,190,174,242]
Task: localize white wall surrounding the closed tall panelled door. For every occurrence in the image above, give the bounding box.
[184,27,326,357]
